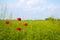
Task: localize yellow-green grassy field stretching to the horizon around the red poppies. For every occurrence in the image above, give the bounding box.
[0,20,60,40]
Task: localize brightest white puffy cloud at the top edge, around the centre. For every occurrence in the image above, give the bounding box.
[17,0,39,8]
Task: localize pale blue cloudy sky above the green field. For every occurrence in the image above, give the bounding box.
[0,0,60,20]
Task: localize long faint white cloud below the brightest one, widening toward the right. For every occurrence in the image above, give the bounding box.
[23,4,57,11]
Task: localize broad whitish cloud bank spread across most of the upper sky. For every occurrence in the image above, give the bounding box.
[5,0,57,11]
